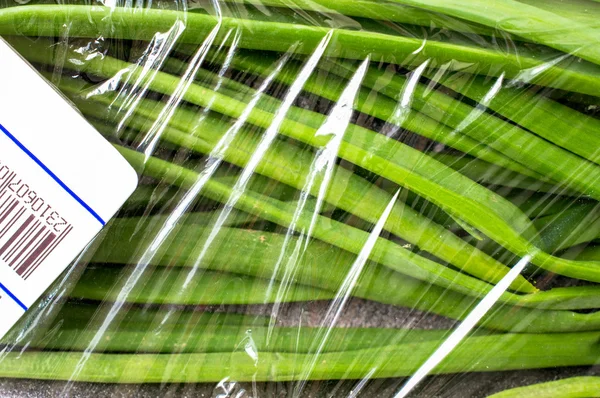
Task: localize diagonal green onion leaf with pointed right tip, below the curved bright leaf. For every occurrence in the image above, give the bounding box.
[62,83,536,292]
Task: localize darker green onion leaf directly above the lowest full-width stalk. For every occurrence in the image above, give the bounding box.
[30,323,448,356]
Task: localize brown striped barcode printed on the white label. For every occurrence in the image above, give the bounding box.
[0,184,73,279]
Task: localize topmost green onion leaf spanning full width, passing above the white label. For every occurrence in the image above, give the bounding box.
[0,5,600,95]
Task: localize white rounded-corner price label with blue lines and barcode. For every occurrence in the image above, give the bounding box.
[0,39,137,337]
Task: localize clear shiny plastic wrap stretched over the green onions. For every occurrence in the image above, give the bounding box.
[0,0,600,398]
